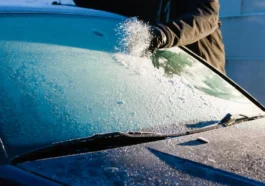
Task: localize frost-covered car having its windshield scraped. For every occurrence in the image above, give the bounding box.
[0,5,265,186]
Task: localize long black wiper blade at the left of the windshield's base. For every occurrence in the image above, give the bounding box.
[12,132,179,164]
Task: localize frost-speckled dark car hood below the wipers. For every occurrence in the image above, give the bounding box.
[19,119,265,185]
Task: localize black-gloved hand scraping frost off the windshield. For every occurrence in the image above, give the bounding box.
[148,26,167,53]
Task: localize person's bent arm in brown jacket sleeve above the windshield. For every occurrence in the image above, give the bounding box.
[158,0,220,48]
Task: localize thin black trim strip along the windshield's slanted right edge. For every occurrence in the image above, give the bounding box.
[179,46,265,111]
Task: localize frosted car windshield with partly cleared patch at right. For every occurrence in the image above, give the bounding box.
[0,14,262,157]
